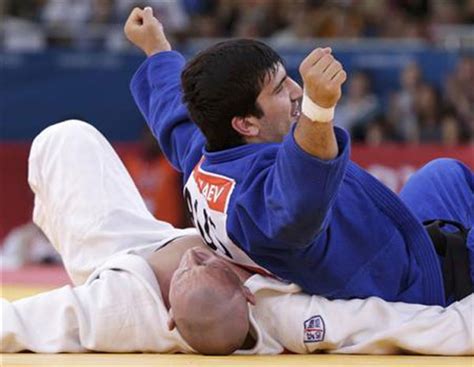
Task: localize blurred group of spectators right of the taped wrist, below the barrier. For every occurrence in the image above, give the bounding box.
[335,56,474,146]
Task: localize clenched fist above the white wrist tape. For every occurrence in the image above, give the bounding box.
[299,48,347,108]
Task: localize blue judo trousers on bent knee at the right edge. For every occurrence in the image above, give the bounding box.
[400,158,474,290]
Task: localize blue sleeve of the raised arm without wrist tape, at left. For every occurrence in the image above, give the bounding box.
[130,51,204,175]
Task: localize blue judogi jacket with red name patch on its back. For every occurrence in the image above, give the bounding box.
[131,51,472,305]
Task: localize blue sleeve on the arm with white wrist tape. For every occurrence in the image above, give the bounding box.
[228,127,350,253]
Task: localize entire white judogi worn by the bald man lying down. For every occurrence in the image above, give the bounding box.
[0,121,474,355]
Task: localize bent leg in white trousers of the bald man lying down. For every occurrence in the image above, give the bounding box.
[28,120,193,284]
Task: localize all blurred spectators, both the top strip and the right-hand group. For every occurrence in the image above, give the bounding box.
[0,0,474,145]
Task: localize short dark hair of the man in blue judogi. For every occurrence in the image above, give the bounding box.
[181,39,283,151]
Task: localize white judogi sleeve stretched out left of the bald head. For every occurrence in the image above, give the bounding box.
[0,255,192,353]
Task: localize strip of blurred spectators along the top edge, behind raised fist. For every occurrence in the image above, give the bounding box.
[0,0,474,45]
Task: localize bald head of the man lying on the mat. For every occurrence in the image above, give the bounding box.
[170,283,250,355]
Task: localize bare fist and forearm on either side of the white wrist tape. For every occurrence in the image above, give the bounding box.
[295,48,346,160]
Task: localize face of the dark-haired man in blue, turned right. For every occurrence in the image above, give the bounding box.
[257,64,303,142]
